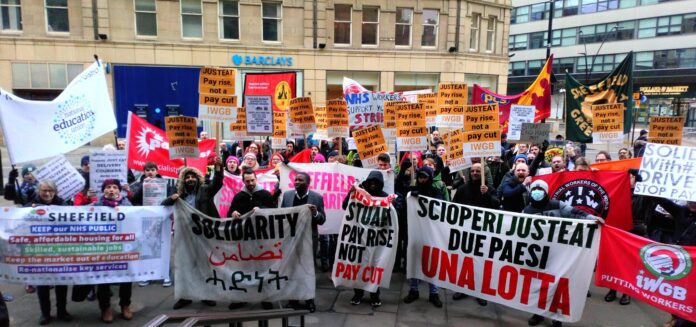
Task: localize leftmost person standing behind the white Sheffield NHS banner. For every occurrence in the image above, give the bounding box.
[24,179,73,325]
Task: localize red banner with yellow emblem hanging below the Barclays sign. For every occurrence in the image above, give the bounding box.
[244,72,297,112]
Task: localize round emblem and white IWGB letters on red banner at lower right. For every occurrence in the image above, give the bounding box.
[636,244,692,300]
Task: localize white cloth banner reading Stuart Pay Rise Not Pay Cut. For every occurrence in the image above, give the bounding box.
[331,187,399,292]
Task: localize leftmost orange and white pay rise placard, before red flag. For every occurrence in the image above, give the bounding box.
[164,116,198,159]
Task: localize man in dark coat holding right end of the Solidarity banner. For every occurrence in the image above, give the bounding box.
[280,172,326,312]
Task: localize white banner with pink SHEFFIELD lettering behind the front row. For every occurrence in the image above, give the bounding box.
[280,163,394,234]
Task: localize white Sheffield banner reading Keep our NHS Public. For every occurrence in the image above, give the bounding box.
[0,206,171,285]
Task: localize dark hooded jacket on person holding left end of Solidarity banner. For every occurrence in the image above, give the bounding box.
[162,167,224,217]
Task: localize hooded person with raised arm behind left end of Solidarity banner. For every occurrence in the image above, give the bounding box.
[162,156,224,310]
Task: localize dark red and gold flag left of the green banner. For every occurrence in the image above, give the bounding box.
[471,55,553,132]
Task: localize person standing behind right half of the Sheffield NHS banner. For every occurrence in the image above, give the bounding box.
[92,179,133,323]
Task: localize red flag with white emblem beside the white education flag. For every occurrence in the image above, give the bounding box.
[126,112,216,178]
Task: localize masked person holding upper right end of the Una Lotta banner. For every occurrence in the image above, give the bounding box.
[522,180,604,327]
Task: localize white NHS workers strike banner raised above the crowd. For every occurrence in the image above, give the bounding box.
[345,92,402,129]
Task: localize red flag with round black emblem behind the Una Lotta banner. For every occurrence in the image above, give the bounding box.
[534,170,633,230]
